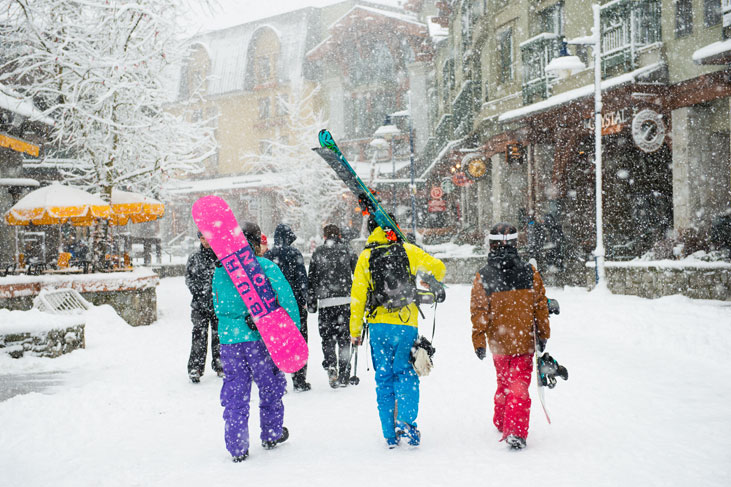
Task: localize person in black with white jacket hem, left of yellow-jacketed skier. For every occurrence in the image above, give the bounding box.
[307,225,358,388]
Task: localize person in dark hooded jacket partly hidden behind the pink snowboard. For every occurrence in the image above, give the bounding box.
[264,223,311,392]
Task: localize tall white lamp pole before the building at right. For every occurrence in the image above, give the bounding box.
[592,4,605,285]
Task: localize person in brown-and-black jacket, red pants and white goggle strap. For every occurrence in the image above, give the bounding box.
[470,223,551,449]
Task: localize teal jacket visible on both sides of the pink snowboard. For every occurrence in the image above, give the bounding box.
[212,257,300,344]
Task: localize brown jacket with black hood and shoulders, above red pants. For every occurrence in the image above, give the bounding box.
[470,247,551,355]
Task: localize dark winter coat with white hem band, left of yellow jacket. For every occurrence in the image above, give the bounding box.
[307,239,358,308]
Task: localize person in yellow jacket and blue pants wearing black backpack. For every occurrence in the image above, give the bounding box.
[350,217,446,448]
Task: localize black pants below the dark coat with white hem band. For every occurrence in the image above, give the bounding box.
[318,304,350,378]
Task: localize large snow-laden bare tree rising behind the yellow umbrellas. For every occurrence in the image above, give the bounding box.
[0,0,215,201]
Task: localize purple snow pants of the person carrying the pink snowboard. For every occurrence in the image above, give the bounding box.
[221,341,287,456]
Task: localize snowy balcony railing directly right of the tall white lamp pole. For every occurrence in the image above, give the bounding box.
[601,0,662,75]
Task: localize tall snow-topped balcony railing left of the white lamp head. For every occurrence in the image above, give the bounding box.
[520,32,561,105]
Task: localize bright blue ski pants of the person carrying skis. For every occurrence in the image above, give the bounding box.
[369,323,419,438]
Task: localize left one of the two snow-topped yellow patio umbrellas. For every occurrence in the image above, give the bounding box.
[5,183,112,225]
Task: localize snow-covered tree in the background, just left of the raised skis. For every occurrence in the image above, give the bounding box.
[245,87,353,242]
